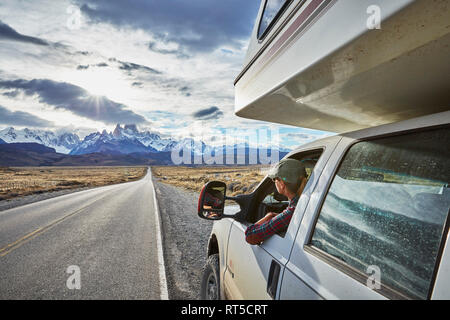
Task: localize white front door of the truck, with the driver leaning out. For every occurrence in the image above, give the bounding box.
[223,137,340,300]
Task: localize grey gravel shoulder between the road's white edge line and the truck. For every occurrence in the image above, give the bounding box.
[154,179,212,300]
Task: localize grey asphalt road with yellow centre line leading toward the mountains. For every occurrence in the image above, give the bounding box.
[0,170,164,299]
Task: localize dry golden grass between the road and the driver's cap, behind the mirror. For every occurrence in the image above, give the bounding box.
[152,165,269,196]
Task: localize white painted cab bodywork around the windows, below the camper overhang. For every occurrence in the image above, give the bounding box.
[206,111,450,300]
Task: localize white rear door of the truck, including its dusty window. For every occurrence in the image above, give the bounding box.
[280,126,450,299]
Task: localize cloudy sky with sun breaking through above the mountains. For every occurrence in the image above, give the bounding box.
[0,0,325,148]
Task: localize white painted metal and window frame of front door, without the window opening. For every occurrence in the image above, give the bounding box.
[219,136,341,299]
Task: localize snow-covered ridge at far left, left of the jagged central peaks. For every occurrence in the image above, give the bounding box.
[0,127,80,154]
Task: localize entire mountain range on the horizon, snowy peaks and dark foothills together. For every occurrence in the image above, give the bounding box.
[0,124,290,166]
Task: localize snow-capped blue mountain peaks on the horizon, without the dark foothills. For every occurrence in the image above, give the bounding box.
[0,124,289,161]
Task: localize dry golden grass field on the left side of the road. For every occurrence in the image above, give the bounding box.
[0,167,147,200]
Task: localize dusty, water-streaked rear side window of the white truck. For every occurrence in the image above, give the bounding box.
[309,128,450,299]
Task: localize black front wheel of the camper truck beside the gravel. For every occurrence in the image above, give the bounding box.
[200,254,220,300]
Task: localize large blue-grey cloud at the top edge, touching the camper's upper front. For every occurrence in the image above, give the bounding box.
[75,0,260,54]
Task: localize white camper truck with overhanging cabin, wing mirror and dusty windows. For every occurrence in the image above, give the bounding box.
[198,0,450,299]
